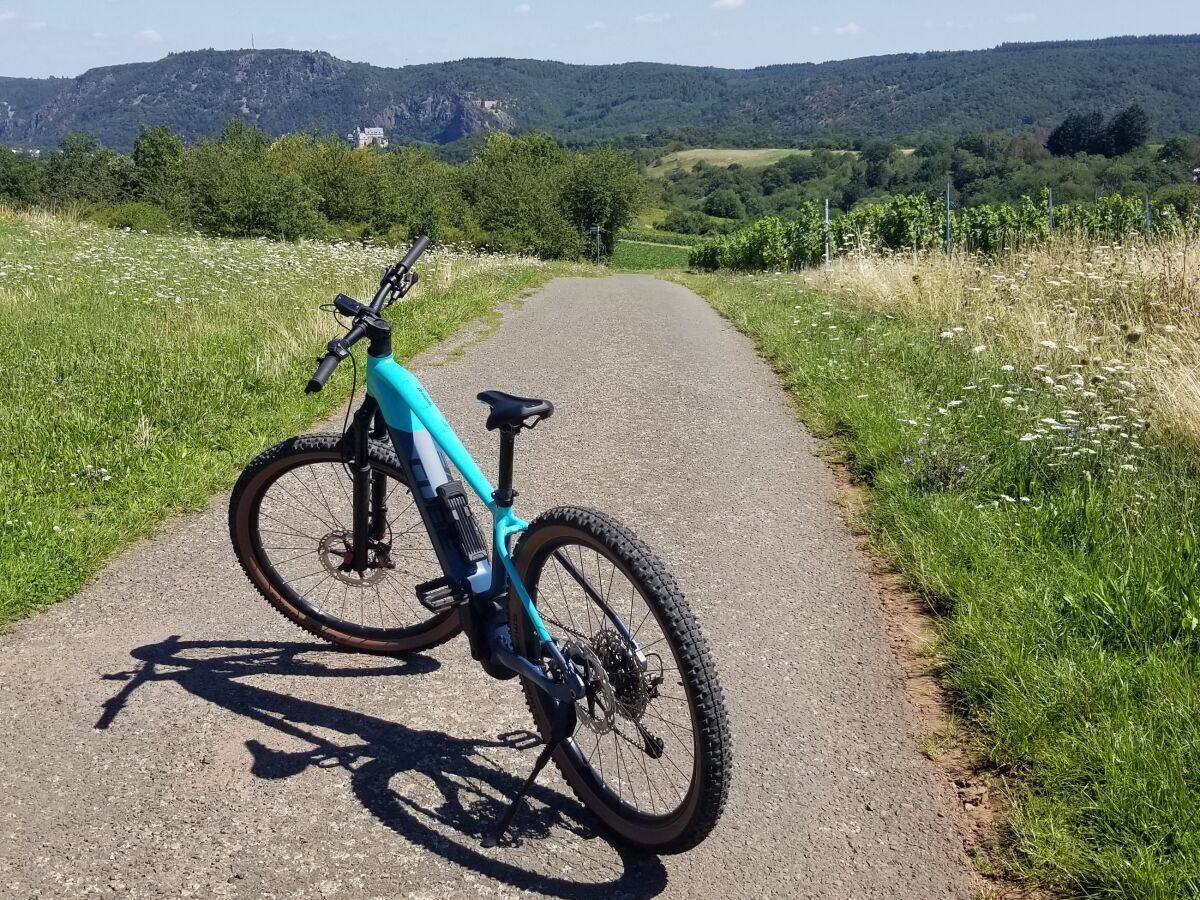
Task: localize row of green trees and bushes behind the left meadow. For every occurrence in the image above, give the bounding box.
[0,119,647,258]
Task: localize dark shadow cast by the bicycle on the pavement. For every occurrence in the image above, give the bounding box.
[96,635,667,900]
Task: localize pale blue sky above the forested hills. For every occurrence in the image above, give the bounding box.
[0,0,1200,76]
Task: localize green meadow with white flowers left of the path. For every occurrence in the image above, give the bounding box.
[0,212,583,629]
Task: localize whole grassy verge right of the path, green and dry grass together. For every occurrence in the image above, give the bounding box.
[677,244,1200,900]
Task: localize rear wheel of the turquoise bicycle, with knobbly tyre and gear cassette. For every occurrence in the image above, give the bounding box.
[510,506,731,853]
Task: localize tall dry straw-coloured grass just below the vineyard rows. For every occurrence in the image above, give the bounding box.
[797,240,1200,444]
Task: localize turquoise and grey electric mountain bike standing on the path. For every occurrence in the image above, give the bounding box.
[229,238,731,853]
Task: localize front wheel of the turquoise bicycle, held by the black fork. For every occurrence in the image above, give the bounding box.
[229,434,458,654]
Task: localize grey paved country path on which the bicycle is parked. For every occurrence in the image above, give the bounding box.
[0,276,970,900]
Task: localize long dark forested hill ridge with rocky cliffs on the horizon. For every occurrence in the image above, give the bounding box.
[0,35,1200,150]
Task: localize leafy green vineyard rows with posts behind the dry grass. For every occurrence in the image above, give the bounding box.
[690,190,1200,271]
